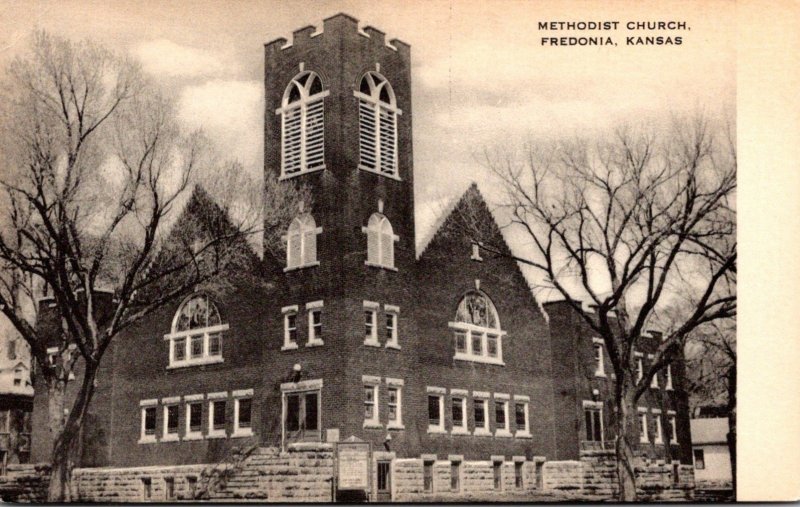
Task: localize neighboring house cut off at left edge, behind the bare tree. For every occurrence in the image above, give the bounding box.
[0,317,33,472]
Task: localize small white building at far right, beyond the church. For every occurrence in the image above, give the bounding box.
[691,417,733,488]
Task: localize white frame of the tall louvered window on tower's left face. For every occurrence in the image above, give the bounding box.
[275,71,330,180]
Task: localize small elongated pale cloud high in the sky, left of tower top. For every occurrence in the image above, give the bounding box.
[133,39,231,77]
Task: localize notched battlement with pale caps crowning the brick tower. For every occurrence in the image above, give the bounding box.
[264,12,411,56]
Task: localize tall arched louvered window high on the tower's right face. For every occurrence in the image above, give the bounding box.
[354,72,401,178]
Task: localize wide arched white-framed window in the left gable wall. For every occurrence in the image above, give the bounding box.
[164,295,229,368]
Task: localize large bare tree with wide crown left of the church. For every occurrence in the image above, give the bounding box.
[0,32,300,501]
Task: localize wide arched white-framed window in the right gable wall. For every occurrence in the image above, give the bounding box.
[448,290,506,365]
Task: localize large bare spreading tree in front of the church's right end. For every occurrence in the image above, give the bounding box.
[460,118,736,501]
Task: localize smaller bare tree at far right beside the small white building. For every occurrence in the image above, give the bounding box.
[687,319,736,495]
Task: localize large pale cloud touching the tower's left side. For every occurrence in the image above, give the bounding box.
[178,79,264,170]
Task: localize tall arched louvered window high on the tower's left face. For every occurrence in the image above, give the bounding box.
[277,71,328,177]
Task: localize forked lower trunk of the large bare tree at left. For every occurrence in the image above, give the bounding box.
[47,367,97,503]
